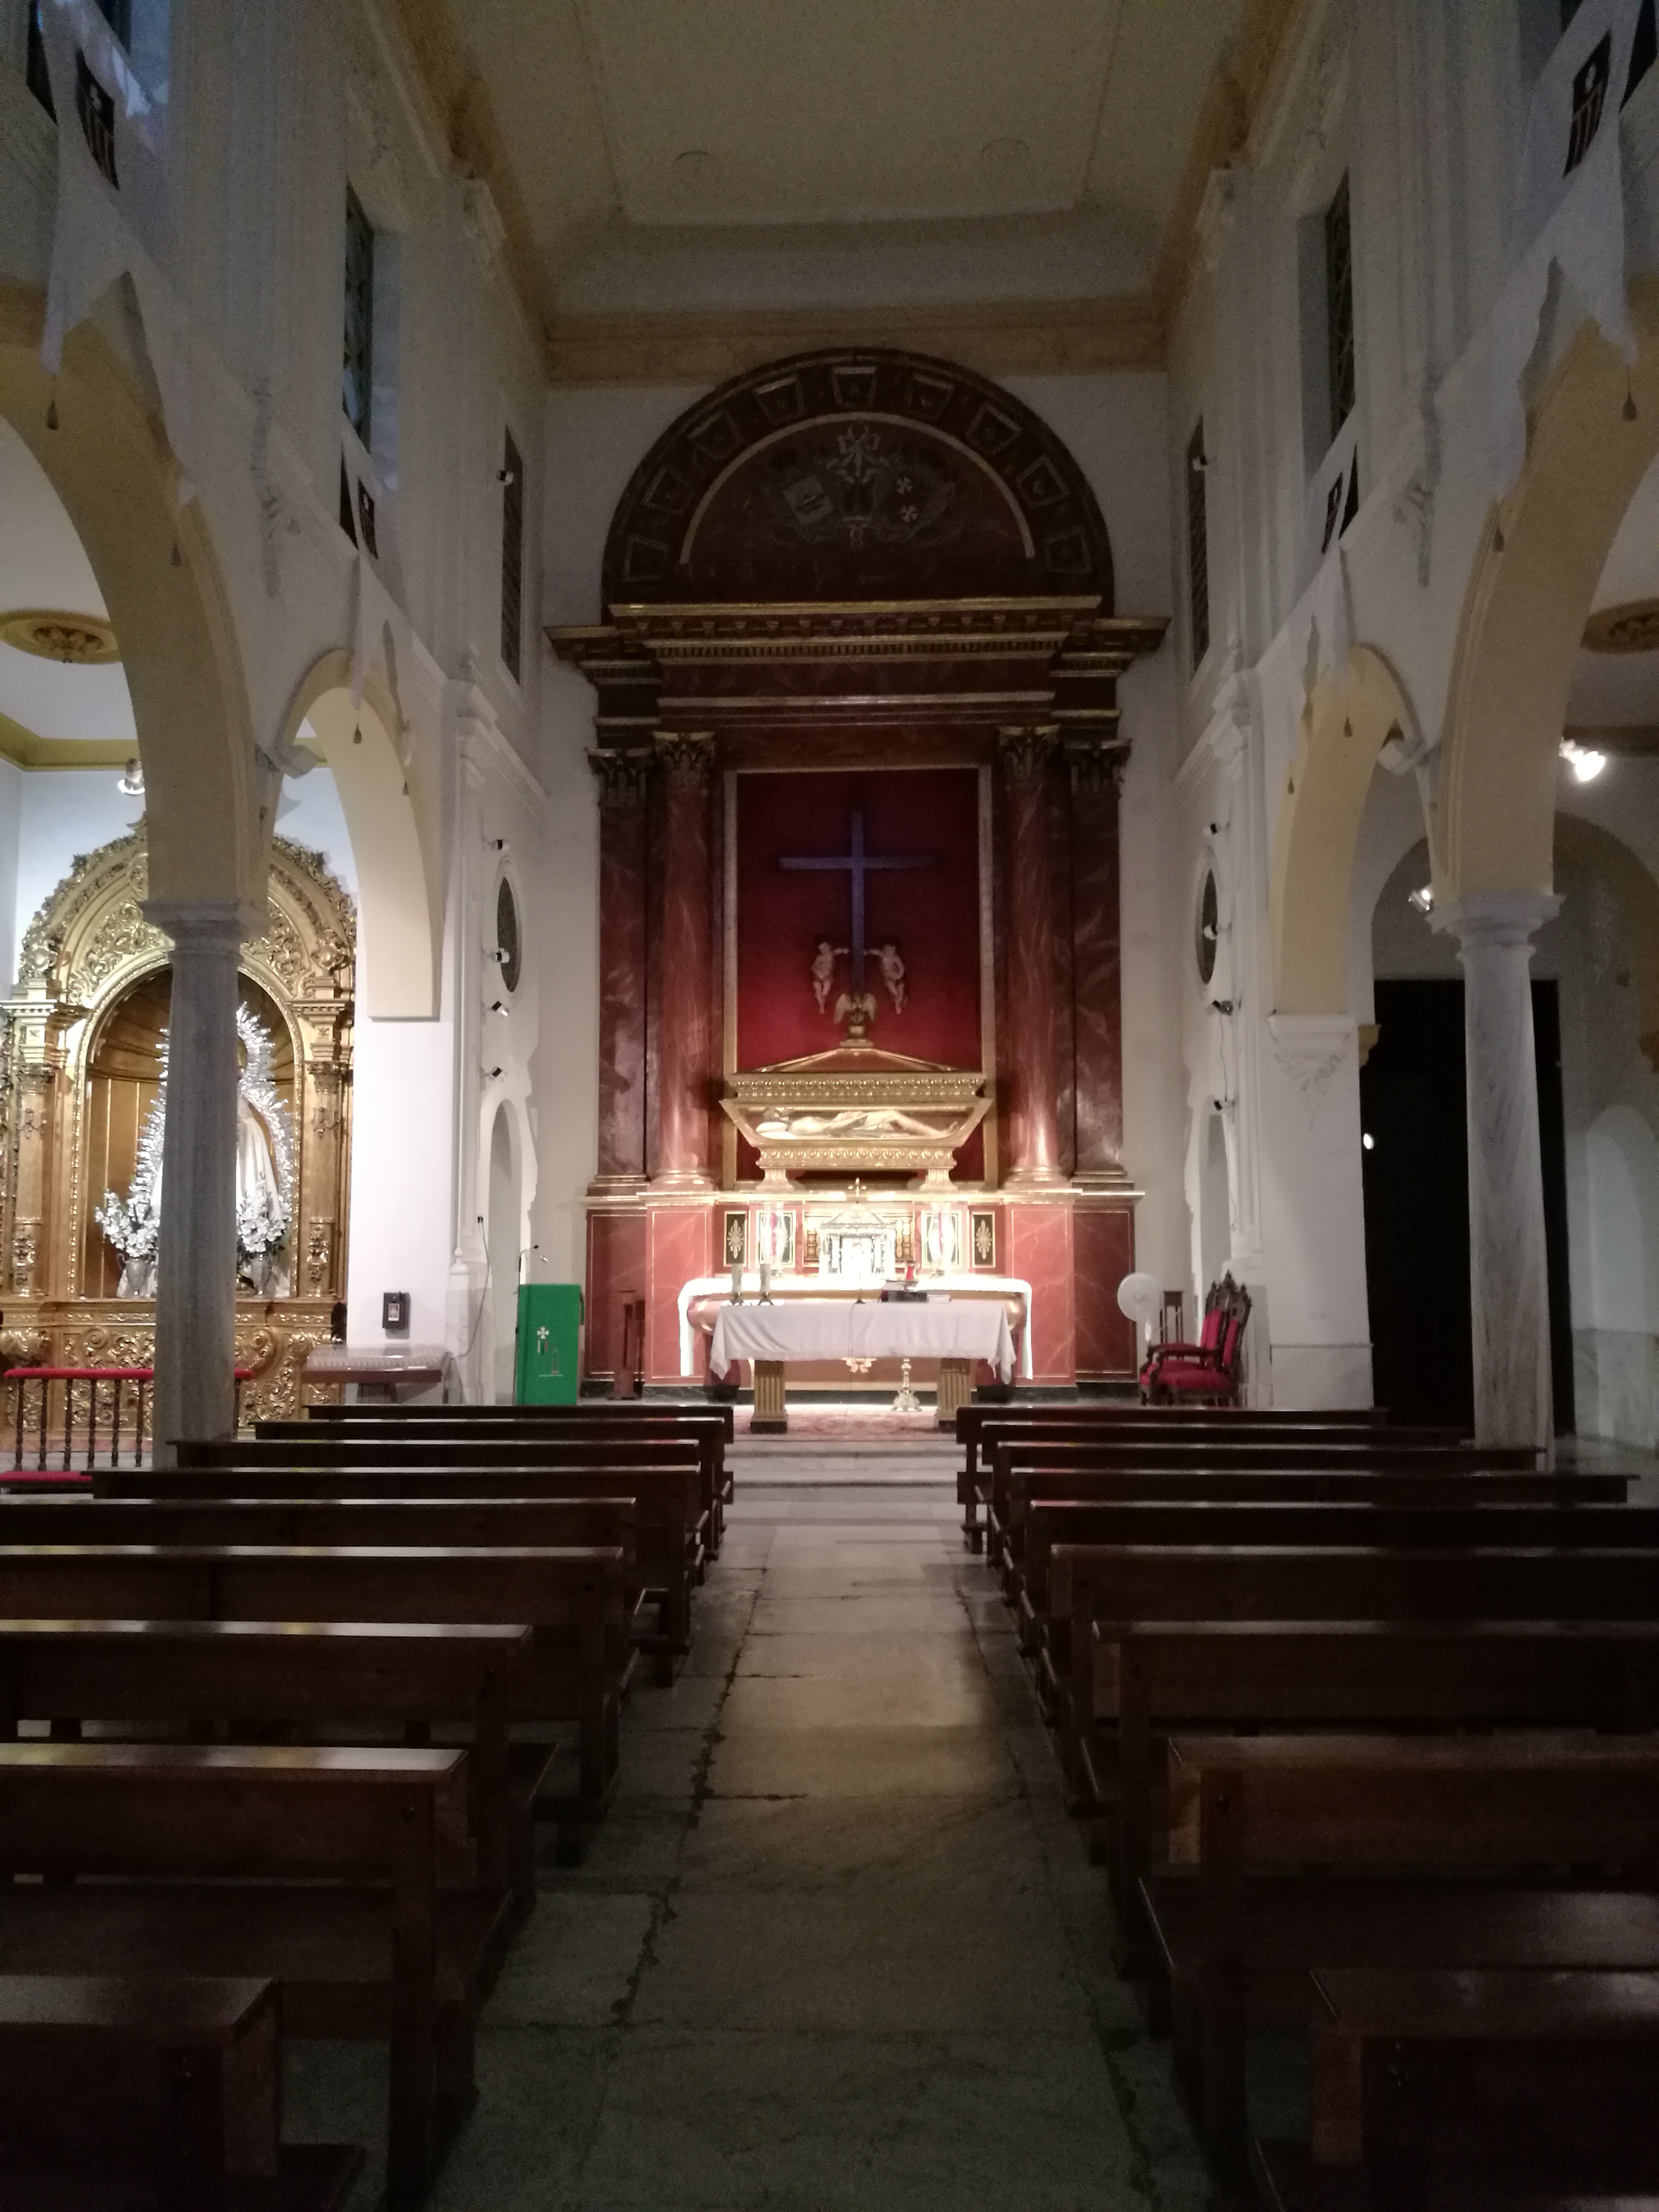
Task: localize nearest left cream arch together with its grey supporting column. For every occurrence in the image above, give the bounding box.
[0,276,265,1456]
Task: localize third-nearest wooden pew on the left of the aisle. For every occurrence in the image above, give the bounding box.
[0,1619,549,1911]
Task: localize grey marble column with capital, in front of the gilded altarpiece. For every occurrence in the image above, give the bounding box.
[144,898,259,1467]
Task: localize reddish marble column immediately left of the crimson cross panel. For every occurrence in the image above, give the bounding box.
[655,732,715,1190]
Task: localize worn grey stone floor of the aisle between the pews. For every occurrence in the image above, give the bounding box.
[288,1444,1206,2212]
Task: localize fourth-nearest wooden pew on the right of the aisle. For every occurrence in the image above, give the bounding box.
[1044,1544,1659,1776]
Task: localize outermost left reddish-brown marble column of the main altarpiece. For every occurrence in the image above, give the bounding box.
[588,752,651,1192]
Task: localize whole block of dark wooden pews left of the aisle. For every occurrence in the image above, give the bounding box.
[0,1403,730,2212]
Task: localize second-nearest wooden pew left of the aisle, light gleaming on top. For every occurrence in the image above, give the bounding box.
[0,1743,487,2208]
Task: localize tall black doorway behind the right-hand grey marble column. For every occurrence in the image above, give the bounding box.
[1360,982,1573,1433]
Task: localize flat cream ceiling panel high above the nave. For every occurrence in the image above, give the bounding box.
[435,0,1256,369]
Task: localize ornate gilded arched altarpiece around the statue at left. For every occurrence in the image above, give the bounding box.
[0,823,356,1427]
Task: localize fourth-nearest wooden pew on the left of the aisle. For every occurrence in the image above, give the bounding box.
[0,1544,630,1822]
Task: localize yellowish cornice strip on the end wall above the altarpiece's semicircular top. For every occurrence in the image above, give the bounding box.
[549,292,1163,385]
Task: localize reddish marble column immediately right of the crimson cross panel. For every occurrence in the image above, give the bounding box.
[998,727,1066,1190]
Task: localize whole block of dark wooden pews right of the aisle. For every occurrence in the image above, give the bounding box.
[958,1405,1659,2212]
